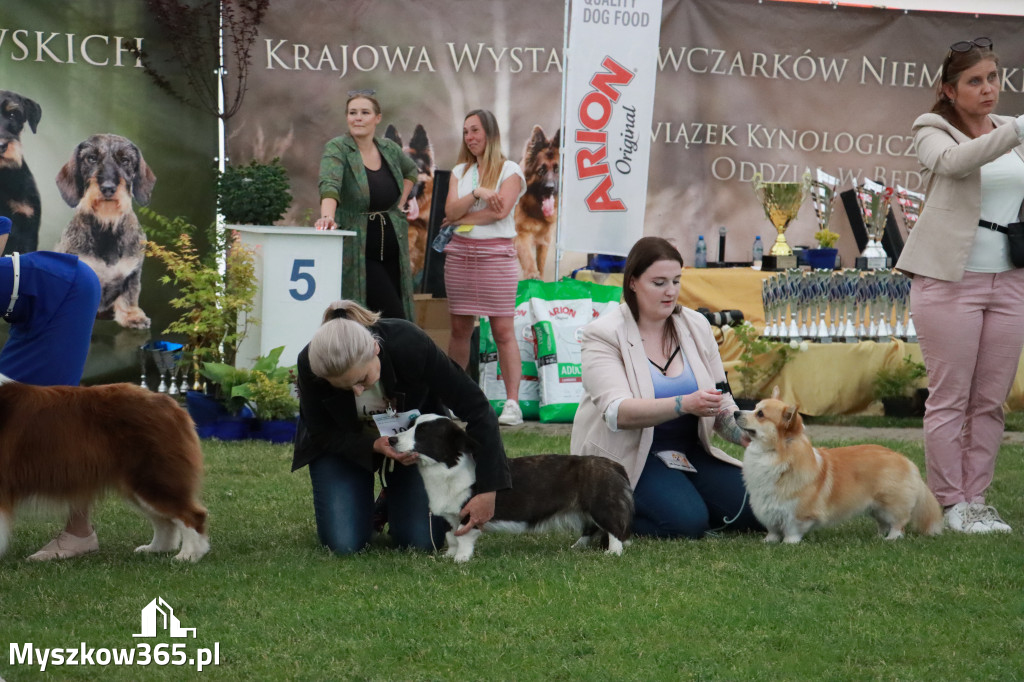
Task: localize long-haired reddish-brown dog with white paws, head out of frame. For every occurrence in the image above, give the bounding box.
[0,375,210,561]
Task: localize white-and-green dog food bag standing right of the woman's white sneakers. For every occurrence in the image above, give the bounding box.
[530,280,594,423]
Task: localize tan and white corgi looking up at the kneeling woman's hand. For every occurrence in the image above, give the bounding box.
[735,388,942,544]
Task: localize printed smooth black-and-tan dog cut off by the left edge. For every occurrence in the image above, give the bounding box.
[0,90,43,253]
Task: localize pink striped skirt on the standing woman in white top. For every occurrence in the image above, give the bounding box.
[444,235,519,317]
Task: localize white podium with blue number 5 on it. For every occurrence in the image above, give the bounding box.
[227,225,355,368]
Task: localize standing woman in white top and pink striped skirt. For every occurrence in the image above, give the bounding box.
[444,110,526,426]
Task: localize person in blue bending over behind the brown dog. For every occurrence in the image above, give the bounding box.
[0,216,100,561]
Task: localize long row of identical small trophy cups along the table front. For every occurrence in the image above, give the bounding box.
[761,268,918,343]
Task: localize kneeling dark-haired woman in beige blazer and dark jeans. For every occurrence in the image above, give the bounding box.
[571,237,763,538]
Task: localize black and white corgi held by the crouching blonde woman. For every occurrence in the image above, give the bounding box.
[389,415,633,562]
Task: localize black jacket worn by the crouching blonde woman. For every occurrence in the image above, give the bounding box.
[292,318,512,493]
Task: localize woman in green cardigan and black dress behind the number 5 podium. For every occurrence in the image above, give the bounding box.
[313,90,419,319]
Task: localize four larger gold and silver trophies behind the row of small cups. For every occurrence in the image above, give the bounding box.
[754,168,925,270]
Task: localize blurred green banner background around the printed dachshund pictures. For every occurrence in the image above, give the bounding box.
[0,0,217,383]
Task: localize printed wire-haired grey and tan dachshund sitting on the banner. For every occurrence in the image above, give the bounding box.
[56,134,157,329]
